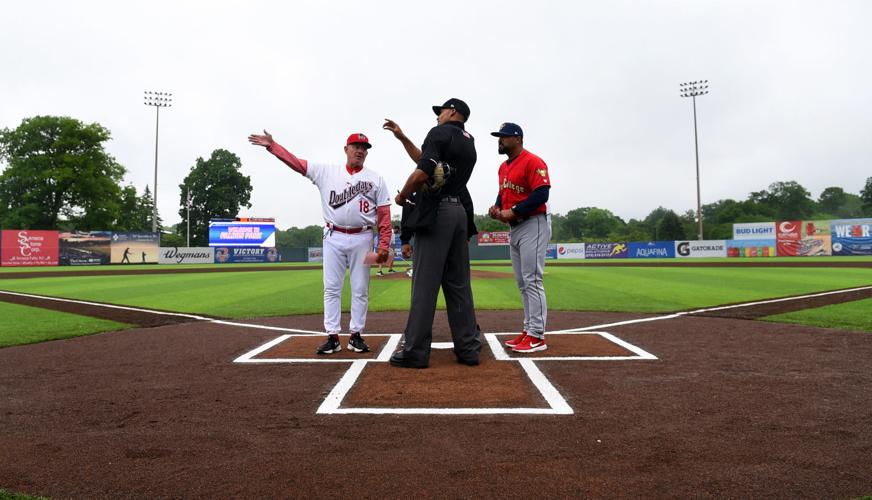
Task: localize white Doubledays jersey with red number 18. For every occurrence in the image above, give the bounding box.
[306,162,391,227]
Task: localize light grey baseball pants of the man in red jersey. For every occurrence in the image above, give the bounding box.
[509,214,551,338]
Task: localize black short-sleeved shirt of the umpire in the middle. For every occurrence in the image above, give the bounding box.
[418,121,476,198]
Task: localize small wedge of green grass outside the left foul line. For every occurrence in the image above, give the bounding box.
[0,302,130,347]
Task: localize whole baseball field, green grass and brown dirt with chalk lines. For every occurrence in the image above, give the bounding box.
[0,258,872,498]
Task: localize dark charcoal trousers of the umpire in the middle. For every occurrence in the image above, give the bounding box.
[403,201,481,365]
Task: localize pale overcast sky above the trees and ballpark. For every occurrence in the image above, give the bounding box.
[0,0,872,229]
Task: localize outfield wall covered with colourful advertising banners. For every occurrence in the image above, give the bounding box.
[0,219,872,266]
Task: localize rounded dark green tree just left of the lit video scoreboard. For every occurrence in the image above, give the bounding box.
[179,149,251,246]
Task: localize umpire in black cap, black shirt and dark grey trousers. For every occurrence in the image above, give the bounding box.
[386,98,481,368]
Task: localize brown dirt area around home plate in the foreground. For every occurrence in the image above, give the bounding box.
[0,296,872,498]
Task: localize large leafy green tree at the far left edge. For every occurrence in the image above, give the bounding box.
[0,116,125,230]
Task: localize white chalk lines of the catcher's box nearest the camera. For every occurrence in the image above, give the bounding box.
[316,359,573,415]
